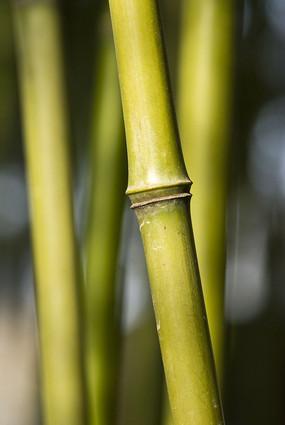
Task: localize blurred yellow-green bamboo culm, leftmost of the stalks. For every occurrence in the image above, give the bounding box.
[13,0,85,425]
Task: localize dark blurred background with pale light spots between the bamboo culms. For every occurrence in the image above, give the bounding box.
[0,0,285,425]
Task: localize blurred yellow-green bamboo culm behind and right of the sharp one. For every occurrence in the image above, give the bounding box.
[178,0,235,384]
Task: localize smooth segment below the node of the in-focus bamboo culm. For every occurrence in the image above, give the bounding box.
[137,200,222,425]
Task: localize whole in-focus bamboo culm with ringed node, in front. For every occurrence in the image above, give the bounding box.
[109,0,223,425]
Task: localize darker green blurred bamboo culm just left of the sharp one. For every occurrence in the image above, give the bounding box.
[86,14,127,425]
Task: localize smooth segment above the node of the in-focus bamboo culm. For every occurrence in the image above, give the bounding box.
[110,0,189,194]
